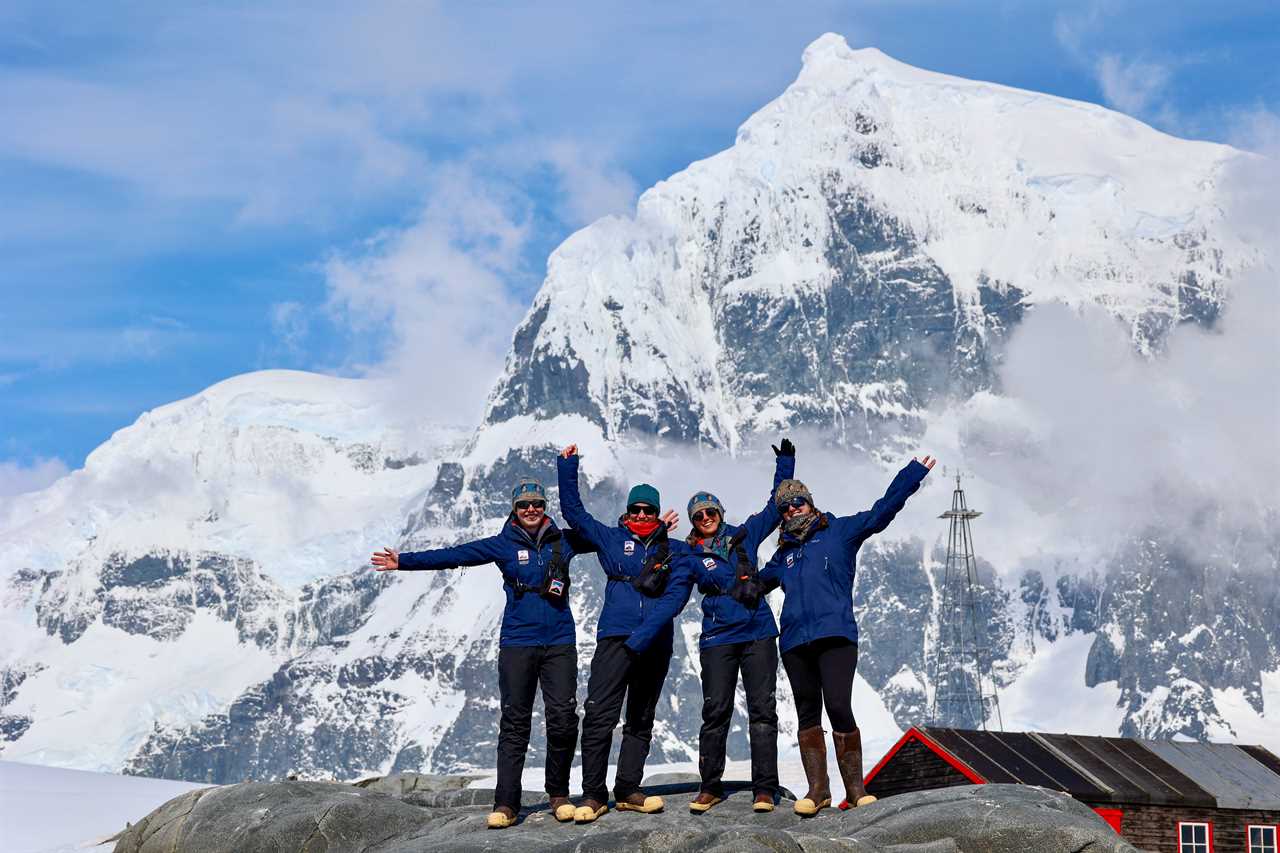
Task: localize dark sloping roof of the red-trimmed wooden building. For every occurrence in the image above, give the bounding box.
[906,726,1280,811]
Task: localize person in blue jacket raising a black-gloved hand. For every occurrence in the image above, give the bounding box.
[685,438,796,813]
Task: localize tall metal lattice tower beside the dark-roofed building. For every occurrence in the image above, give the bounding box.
[928,474,1005,731]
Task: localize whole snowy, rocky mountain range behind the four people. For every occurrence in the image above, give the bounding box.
[0,36,1280,783]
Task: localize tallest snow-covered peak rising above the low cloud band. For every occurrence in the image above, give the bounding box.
[486,35,1260,448]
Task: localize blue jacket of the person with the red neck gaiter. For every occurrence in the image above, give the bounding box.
[556,456,692,652]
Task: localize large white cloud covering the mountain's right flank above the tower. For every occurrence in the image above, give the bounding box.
[963,140,1280,565]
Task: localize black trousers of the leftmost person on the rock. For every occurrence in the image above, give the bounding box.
[493,644,577,812]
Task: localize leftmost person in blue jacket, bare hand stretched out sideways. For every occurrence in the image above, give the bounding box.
[372,479,591,829]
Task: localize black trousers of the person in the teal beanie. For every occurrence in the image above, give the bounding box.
[582,637,671,803]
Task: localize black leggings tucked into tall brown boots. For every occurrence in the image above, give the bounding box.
[782,637,858,731]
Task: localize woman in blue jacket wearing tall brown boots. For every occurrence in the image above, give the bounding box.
[760,456,934,815]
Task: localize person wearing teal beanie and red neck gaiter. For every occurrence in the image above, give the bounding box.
[556,444,692,824]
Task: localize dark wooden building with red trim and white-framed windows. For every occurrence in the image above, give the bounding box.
[867,727,1280,853]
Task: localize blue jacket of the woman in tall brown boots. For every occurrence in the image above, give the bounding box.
[760,460,929,652]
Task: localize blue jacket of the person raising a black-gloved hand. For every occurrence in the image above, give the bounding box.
[684,456,796,648]
